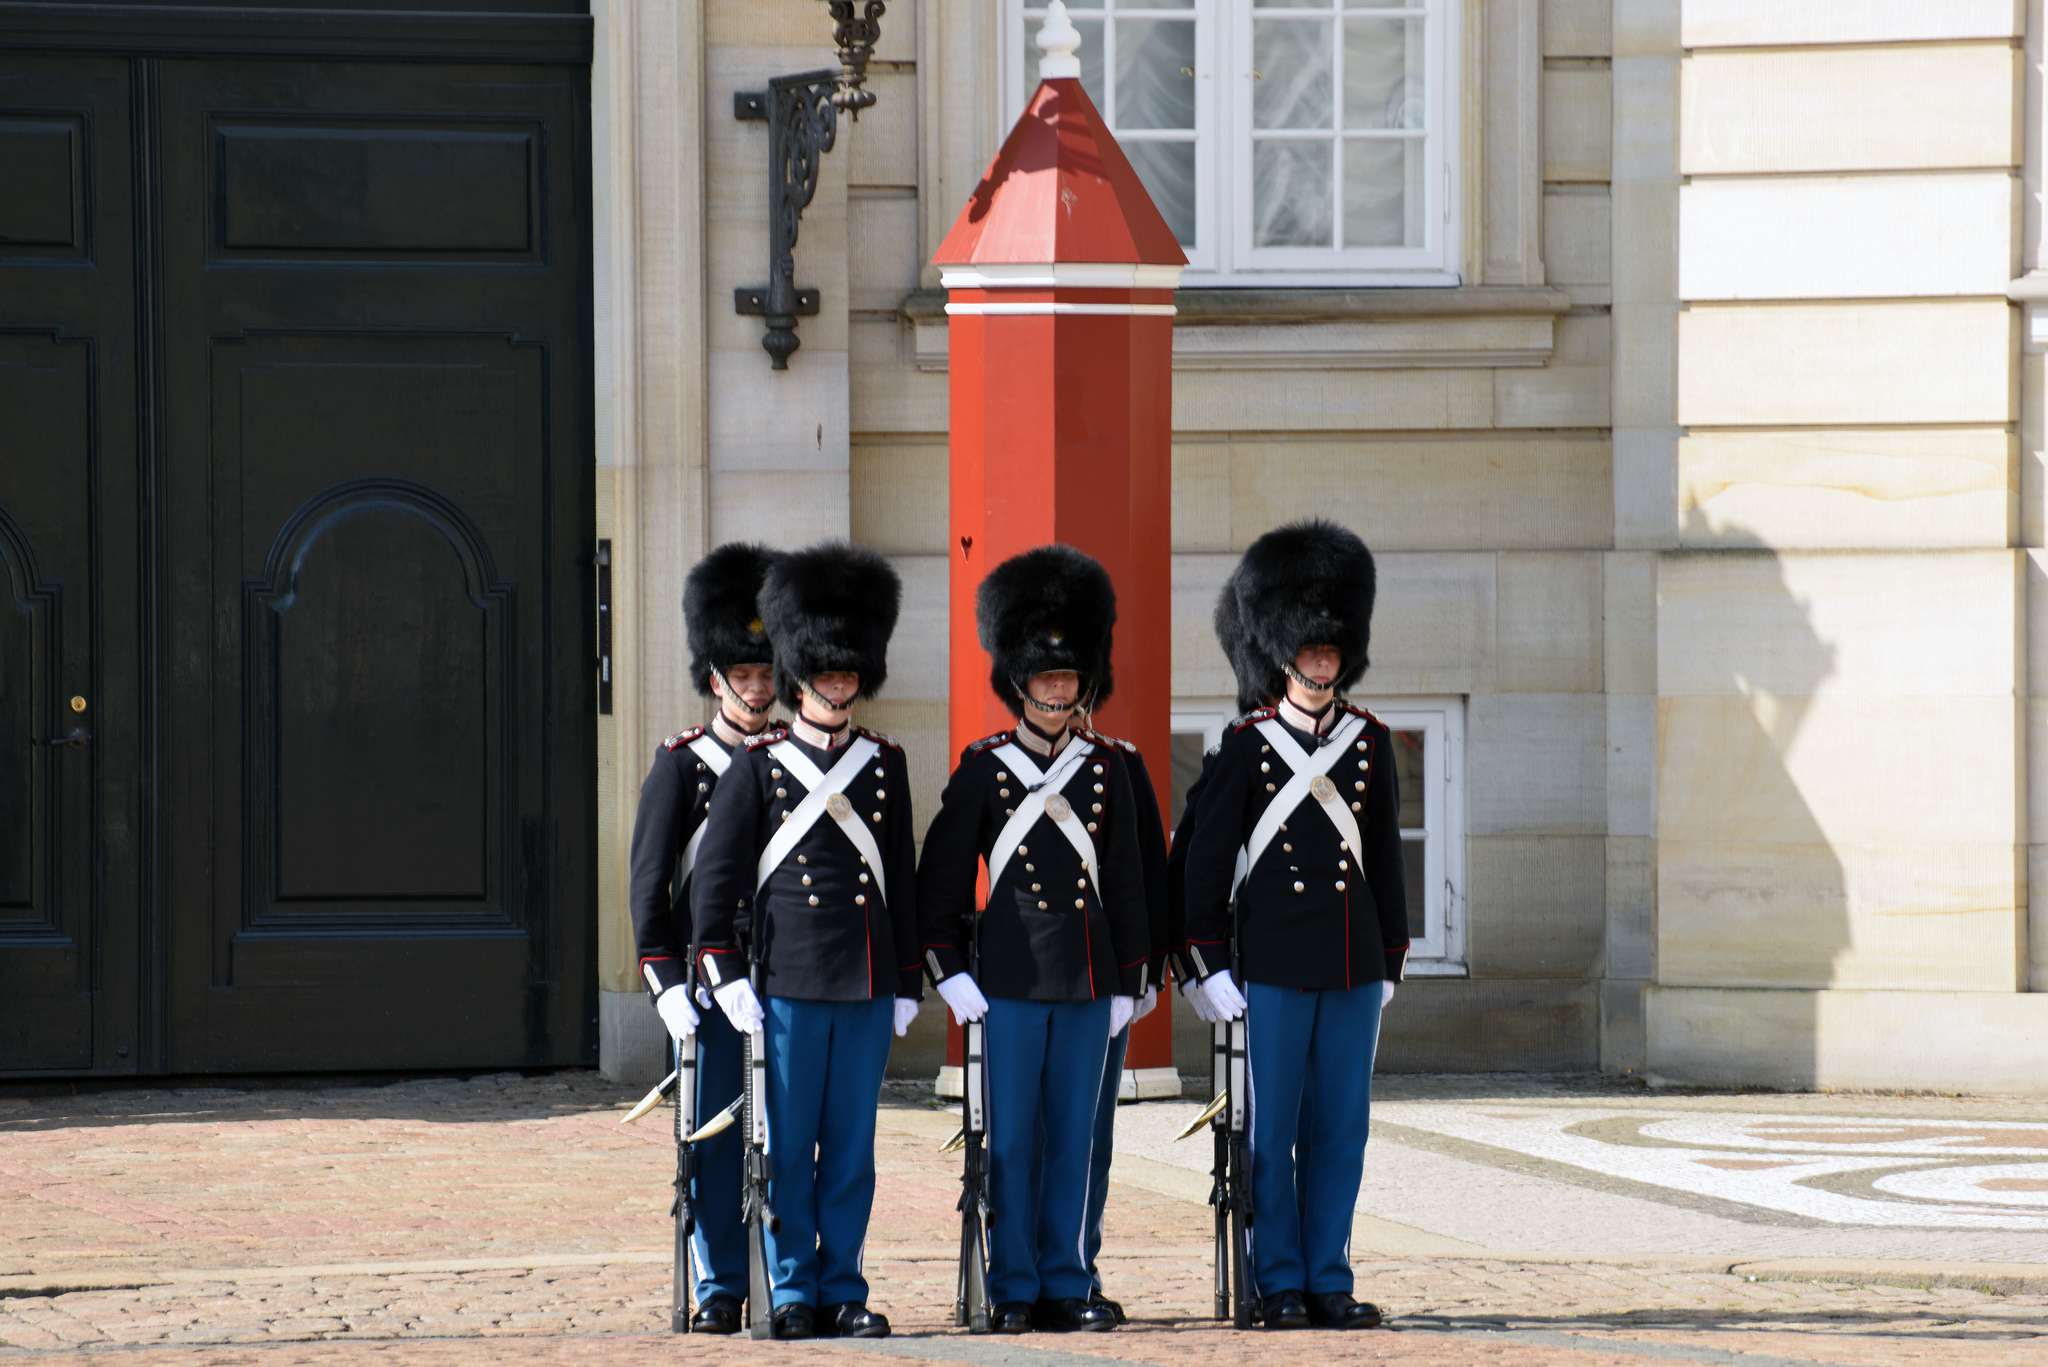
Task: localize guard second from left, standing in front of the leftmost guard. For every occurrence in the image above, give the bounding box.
[690,543,924,1338]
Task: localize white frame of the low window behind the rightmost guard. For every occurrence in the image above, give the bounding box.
[1171,697,1468,978]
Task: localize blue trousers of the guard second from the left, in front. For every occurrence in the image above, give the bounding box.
[766,996,895,1308]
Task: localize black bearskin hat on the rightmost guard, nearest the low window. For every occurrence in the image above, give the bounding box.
[1229,519,1372,693]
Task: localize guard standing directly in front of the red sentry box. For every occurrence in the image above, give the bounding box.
[918,545,1157,1334]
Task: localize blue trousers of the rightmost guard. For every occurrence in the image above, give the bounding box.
[1245,982,1380,1295]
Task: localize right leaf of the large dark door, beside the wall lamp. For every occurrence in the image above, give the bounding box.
[160,61,596,1070]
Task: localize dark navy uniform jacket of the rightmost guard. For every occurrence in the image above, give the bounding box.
[1186,703,1409,988]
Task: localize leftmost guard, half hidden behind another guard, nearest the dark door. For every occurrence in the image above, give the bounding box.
[633,541,776,1334]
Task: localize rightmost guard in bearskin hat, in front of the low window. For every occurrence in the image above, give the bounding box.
[1186,521,1409,1328]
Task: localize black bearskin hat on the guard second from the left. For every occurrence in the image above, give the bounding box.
[762,541,903,707]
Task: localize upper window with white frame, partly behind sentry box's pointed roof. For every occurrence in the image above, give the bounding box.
[1004,0,1456,285]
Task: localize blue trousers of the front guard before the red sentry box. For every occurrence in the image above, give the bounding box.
[987,996,1110,1306]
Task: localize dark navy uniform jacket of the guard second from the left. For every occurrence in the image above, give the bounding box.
[690,726,924,1002]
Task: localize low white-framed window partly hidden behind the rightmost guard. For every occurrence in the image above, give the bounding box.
[1171,697,1464,978]
